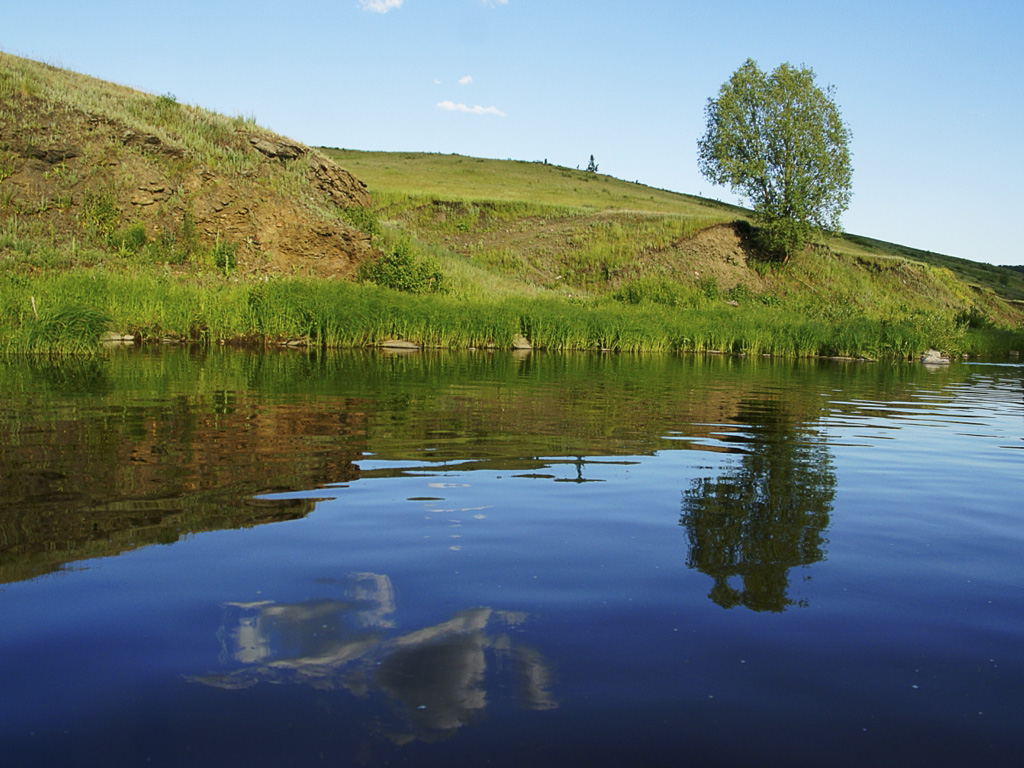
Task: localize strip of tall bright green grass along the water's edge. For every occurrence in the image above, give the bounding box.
[6,269,999,357]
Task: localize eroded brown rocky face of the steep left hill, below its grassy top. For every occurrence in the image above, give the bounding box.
[0,86,372,278]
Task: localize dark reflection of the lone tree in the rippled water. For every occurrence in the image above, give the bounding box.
[680,400,836,612]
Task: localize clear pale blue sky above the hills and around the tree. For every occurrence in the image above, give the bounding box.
[0,0,1024,264]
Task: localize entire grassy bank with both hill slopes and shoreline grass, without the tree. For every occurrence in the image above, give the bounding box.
[0,53,1024,356]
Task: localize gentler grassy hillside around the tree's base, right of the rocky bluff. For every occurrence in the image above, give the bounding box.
[324,148,1024,327]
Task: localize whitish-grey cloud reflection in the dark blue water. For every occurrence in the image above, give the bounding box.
[188,573,558,742]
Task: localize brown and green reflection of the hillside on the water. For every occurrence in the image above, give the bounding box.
[0,350,847,581]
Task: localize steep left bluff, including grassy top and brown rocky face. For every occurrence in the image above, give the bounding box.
[0,53,370,276]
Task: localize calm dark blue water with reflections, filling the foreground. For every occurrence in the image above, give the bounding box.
[0,350,1024,767]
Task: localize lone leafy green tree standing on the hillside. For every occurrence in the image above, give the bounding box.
[697,58,853,262]
